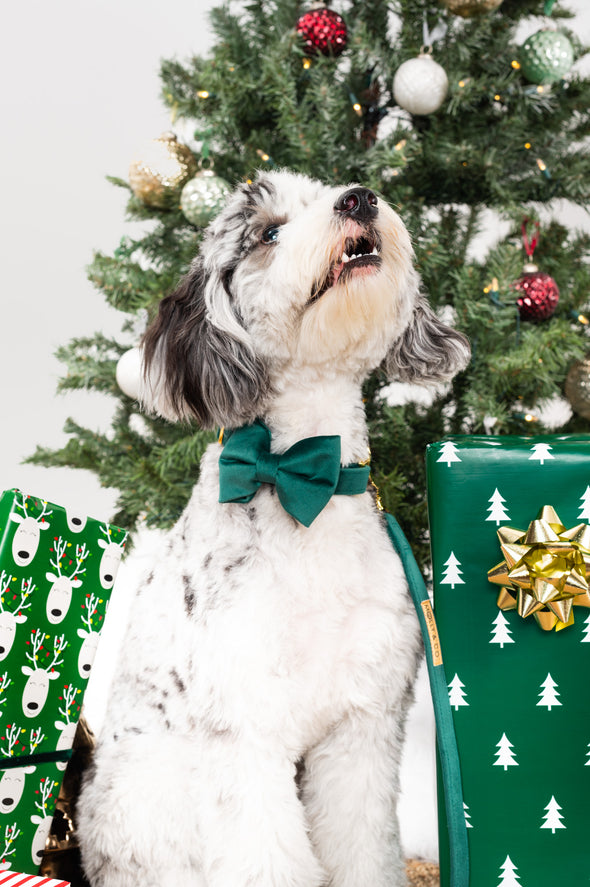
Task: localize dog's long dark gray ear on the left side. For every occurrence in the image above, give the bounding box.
[140,259,269,428]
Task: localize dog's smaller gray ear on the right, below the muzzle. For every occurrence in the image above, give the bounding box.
[383,295,471,383]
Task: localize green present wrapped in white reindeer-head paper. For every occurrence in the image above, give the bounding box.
[0,490,127,872]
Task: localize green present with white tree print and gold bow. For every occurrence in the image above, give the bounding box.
[427,436,590,887]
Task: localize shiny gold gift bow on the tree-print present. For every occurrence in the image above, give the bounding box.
[488,505,590,631]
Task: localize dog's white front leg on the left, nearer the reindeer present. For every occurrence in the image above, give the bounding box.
[199,735,326,887]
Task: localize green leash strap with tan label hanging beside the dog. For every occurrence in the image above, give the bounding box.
[384,512,469,887]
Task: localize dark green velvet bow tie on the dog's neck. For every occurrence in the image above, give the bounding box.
[219,420,370,527]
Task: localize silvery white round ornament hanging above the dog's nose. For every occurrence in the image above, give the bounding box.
[393,46,449,115]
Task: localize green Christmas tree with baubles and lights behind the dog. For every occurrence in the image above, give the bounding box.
[30,0,590,561]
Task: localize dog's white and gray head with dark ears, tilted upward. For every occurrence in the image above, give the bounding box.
[142,172,469,428]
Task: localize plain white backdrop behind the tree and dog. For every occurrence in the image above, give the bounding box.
[0,0,590,858]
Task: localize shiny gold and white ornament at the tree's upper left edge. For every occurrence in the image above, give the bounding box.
[129,132,198,209]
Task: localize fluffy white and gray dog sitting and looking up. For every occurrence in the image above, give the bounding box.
[79,172,469,887]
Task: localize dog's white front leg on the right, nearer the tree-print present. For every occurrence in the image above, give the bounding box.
[303,711,406,887]
